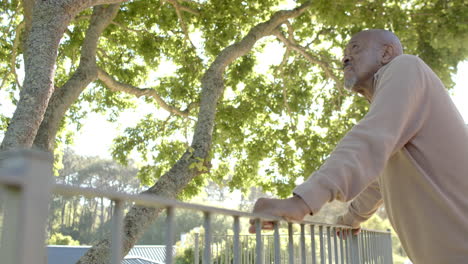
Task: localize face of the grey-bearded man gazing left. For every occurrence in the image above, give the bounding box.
[343,33,381,91]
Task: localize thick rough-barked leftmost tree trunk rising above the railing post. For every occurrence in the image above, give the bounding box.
[1,1,72,150]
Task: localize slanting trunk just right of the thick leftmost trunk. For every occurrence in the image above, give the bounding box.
[34,4,119,151]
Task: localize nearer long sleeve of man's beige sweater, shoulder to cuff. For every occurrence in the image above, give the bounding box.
[294,55,427,214]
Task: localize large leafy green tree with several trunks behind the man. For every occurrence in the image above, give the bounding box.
[0,0,468,263]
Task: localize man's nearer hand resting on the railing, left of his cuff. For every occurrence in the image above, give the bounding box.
[249,196,310,233]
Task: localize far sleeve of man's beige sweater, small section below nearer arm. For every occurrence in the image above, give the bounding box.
[337,181,383,228]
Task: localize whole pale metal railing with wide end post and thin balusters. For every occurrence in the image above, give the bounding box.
[0,150,392,264]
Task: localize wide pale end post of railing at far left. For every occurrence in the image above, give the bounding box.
[0,149,53,264]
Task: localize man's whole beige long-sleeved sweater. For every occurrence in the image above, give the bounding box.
[294,55,468,264]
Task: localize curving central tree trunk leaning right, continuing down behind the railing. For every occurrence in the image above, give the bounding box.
[77,2,311,264]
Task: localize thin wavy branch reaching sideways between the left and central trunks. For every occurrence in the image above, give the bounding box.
[98,68,189,118]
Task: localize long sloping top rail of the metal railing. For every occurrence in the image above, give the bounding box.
[0,175,390,234]
